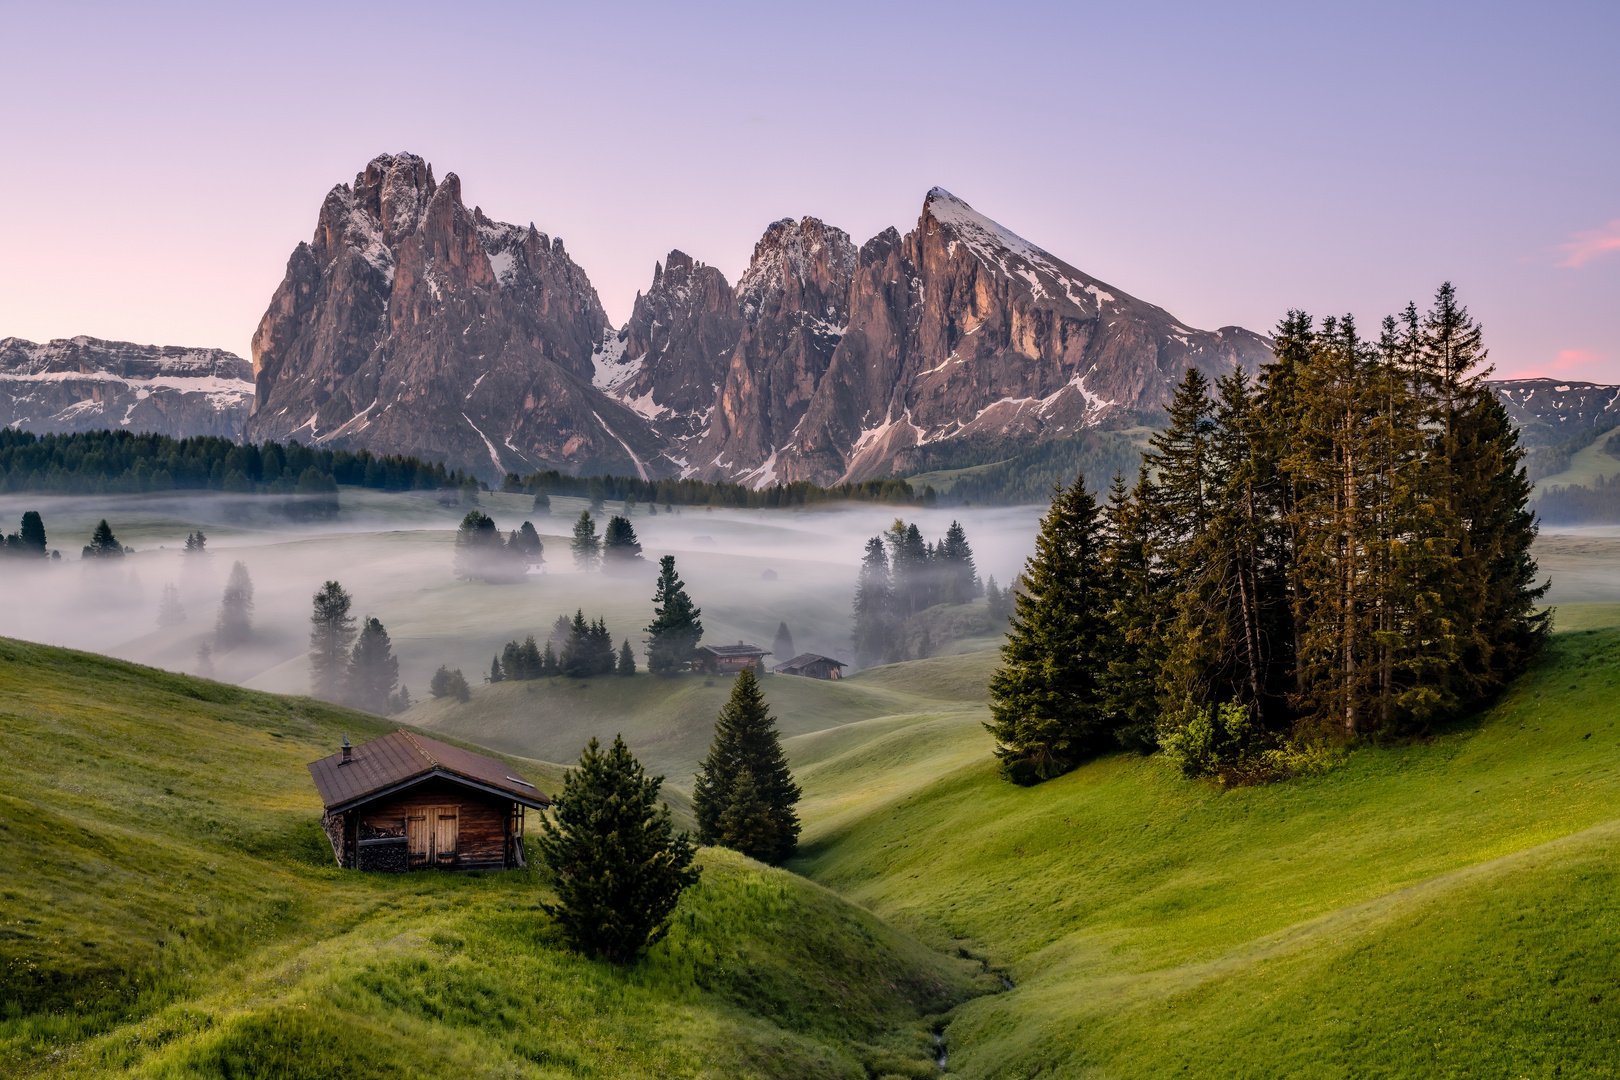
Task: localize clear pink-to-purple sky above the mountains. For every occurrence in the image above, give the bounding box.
[0,0,1620,381]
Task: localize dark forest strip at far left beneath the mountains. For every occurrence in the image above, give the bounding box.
[0,427,467,495]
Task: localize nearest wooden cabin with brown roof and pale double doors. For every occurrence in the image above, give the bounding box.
[309,732,551,873]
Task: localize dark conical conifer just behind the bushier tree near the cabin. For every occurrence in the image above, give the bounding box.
[692,667,800,863]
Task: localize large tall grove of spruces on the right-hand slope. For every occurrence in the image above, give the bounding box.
[991,285,1547,782]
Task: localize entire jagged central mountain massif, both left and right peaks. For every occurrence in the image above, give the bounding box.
[246,154,1270,486]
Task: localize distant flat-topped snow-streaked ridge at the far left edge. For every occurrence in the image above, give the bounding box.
[0,337,253,439]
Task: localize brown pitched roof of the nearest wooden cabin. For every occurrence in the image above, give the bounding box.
[309,732,551,813]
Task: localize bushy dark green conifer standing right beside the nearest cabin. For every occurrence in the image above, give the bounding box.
[539,737,698,963]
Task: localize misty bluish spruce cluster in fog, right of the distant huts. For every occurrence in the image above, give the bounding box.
[854,518,983,667]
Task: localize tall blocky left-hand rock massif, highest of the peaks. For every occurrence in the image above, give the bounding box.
[246,154,676,478]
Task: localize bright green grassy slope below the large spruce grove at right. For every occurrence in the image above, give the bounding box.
[791,631,1620,1077]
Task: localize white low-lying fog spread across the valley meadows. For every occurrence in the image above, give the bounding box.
[0,489,1042,699]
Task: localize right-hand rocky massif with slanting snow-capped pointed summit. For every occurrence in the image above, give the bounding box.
[596,188,1270,484]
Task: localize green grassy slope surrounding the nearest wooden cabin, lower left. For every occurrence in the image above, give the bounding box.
[0,640,970,1077]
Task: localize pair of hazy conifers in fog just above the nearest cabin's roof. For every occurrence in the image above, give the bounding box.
[306,582,411,714]
